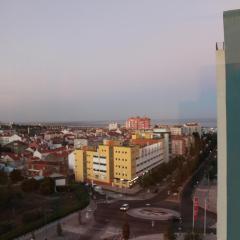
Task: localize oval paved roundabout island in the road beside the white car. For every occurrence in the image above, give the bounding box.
[127,207,180,221]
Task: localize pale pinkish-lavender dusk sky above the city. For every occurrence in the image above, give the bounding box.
[0,0,240,122]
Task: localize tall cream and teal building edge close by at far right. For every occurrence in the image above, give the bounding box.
[216,10,240,240]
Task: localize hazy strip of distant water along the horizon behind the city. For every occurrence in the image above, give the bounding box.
[50,119,217,128]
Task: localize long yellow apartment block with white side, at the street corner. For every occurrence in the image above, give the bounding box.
[75,139,164,188]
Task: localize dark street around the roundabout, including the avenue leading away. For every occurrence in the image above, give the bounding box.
[16,149,216,240]
